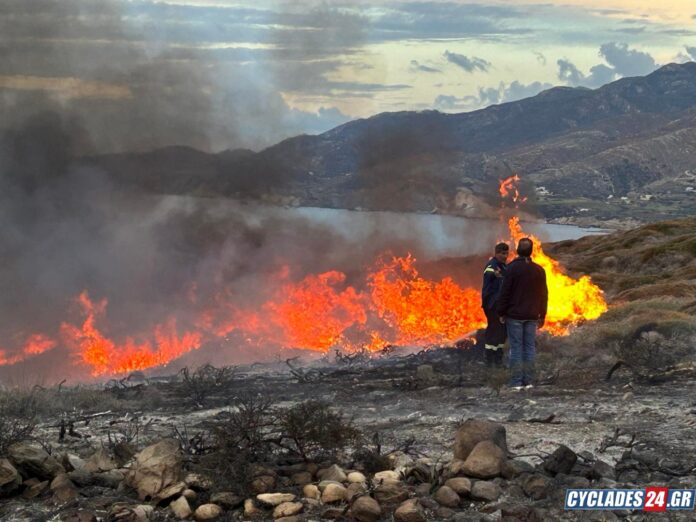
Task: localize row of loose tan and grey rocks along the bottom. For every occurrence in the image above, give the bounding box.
[0,420,617,522]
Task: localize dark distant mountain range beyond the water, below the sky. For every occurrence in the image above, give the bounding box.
[85,63,696,223]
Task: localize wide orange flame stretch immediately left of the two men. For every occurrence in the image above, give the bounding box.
[199,255,485,351]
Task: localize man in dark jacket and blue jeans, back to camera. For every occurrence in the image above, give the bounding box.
[497,238,548,390]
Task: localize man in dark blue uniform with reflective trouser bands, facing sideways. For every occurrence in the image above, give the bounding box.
[481,243,510,367]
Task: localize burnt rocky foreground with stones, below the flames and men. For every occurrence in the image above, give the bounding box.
[0,343,696,522]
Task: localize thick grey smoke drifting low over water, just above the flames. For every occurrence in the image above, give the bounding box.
[0,113,502,378]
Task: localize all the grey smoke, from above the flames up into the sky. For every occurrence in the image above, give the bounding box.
[0,0,503,384]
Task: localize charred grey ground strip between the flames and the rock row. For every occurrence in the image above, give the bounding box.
[0,342,696,520]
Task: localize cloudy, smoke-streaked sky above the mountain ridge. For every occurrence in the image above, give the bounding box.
[0,0,696,152]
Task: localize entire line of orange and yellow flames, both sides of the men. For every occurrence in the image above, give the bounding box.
[0,175,607,376]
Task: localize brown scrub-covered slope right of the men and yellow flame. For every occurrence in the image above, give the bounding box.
[542,217,696,383]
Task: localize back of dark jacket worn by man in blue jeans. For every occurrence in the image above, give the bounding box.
[498,257,548,321]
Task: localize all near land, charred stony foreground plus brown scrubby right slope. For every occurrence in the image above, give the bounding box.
[0,218,696,522]
